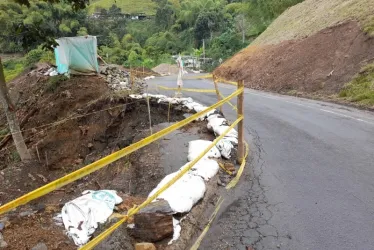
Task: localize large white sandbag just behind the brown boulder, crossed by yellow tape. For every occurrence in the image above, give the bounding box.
[148,171,206,213]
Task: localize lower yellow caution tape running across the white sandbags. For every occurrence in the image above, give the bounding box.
[80,116,243,250]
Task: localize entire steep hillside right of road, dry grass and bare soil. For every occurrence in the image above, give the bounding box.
[214,0,374,108]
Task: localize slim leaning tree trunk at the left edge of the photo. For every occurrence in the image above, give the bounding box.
[0,58,31,162]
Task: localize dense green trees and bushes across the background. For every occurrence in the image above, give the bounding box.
[0,0,302,80]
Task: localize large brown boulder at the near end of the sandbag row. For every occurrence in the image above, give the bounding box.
[131,213,174,242]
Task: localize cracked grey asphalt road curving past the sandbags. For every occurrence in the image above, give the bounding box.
[150,77,374,250]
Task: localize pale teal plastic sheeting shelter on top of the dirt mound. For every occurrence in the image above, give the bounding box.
[55,36,99,74]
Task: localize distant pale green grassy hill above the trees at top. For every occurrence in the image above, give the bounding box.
[88,0,156,15]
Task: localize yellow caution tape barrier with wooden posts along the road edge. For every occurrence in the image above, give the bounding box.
[0,73,249,250]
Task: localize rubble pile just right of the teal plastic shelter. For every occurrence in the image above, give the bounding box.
[100,65,146,93]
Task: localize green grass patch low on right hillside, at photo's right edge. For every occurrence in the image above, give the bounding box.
[339,64,374,106]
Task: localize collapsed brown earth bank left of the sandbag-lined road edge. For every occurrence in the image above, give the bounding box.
[0,67,237,249]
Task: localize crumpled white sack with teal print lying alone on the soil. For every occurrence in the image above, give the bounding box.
[61,190,122,246]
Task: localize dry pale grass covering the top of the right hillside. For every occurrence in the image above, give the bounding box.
[253,0,374,45]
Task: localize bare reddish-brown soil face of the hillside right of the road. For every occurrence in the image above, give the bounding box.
[214,21,374,96]
